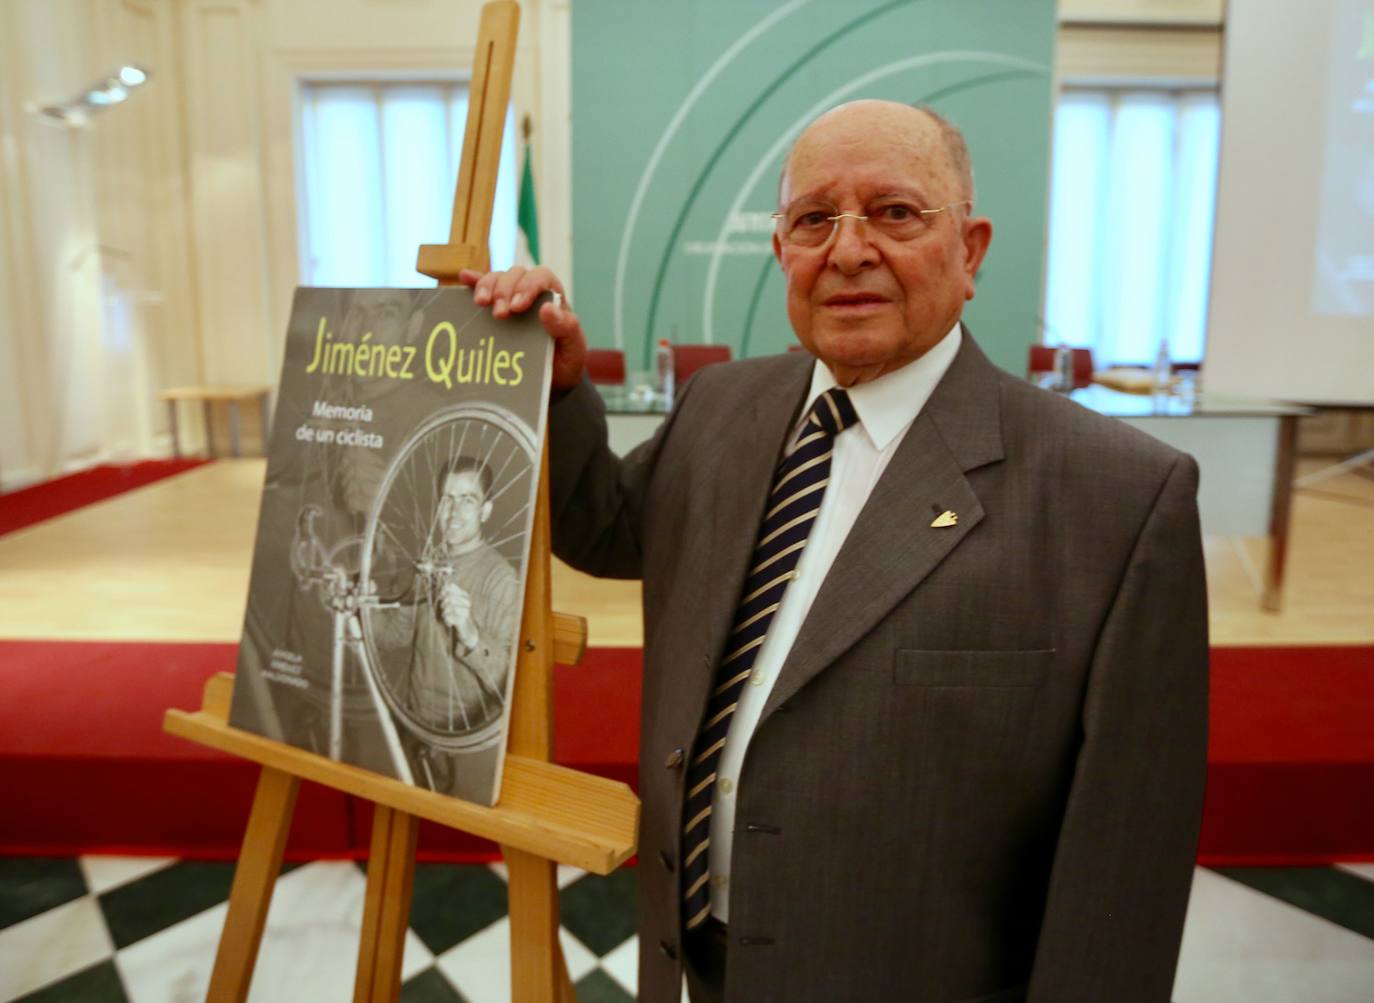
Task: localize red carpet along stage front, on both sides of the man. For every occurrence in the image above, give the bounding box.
[0,642,1374,866]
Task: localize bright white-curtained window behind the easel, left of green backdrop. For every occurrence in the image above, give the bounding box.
[301,82,517,286]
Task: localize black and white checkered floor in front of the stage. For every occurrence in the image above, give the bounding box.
[0,857,1374,1003]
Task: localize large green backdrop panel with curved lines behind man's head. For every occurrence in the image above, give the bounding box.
[573,0,1055,372]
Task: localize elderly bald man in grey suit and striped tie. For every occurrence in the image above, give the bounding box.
[464,100,1206,1003]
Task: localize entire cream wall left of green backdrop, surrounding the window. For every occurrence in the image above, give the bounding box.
[0,0,572,489]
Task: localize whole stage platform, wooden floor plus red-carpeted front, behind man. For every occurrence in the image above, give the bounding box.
[0,460,1374,864]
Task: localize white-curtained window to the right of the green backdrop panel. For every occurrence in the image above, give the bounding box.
[1044,89,1220,365]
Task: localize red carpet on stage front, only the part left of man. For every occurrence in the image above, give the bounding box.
[0,640,639,860]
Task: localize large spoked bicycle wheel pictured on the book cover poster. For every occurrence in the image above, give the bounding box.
[359,404,536,750]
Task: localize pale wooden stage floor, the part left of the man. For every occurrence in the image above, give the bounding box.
[0,459,643,647]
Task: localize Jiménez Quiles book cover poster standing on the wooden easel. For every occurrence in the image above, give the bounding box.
[229,287,551,805]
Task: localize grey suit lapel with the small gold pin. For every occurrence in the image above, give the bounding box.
[756,331,1002,719]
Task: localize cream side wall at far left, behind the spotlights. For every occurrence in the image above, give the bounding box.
[0,0,196,488]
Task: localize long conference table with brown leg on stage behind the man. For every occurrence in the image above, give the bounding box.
[596,378,1311,613]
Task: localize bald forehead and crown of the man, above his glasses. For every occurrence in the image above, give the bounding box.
[779,111,955,205]
